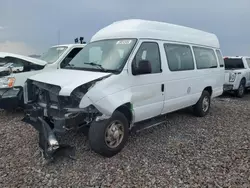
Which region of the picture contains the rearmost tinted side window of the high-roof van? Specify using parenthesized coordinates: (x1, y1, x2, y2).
(193, 47, 218, 69)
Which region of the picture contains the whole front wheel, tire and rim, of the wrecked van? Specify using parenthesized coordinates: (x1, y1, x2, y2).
(89, 111, 129, 157)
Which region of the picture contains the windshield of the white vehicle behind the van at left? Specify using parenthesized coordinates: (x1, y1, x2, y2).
(40, 46, 68, 63)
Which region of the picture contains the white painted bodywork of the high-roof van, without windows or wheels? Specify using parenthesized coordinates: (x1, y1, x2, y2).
(25, 20, 225, 122)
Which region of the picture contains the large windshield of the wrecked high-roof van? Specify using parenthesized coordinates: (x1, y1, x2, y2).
(65, 39, 136, 72)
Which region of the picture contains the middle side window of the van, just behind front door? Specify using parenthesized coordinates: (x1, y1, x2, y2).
(164, 44, 194, 71)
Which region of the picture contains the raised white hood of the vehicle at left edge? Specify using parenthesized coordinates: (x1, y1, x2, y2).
(0, 52, 47, 66)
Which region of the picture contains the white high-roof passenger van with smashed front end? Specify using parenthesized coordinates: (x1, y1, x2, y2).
(23, 19, 225, 158)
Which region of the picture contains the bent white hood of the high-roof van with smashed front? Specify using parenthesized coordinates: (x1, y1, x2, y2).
(29, 69, 111, 96)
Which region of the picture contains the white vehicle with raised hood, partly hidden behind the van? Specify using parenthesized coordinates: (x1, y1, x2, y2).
(0, 44, 85, 110)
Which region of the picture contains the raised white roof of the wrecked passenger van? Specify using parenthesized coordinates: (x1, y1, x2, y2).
(91, 19, 220, 48)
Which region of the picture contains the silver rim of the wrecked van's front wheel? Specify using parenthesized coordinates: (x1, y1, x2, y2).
(105, 120, 124, 148)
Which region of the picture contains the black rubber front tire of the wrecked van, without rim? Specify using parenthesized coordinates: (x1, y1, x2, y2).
(89, 111, 129, 157)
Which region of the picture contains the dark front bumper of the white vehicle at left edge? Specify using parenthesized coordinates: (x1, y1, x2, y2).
(0, 87, 23, 110)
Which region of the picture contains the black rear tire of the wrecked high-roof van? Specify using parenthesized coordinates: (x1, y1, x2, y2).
(194, 90, 211, 117)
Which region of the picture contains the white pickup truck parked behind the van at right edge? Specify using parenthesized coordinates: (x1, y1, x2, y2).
(224, 56, 250, 98)
